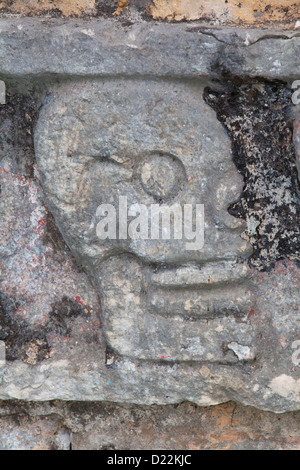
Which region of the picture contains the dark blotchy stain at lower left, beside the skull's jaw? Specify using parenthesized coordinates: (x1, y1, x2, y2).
(0, 292, 91, 365)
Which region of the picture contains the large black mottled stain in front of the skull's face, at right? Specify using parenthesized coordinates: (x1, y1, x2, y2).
(204, 71, 300, 271)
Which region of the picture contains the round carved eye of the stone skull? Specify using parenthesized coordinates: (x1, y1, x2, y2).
(139, 153, 186, 200)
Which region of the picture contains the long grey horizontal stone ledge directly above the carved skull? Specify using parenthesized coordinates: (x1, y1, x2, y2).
(0, 18, 300, 79)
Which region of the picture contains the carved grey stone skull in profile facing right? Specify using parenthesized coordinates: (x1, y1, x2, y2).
(35, 81, 255, 363)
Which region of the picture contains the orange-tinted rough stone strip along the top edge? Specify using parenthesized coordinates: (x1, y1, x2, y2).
(0, 0, 299, 28)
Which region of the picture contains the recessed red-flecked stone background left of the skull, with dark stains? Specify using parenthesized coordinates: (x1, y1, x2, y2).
(0, 94, 99, 364)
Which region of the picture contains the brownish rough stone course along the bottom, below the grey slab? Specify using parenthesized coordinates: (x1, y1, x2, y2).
(0, 402, 300, 450)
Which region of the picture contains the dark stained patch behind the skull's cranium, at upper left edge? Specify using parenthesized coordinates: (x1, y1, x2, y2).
(0, 93, 38, 178)
